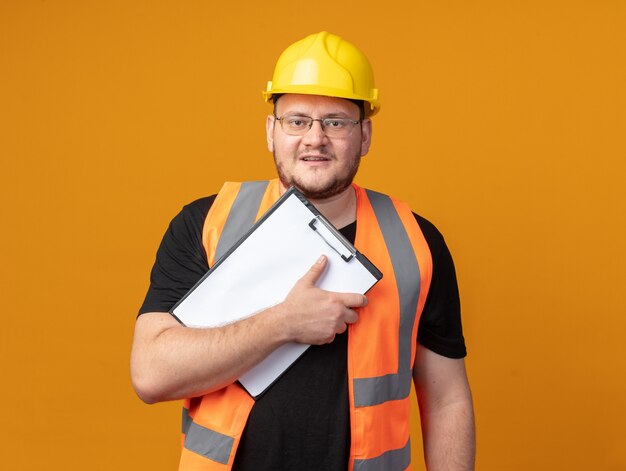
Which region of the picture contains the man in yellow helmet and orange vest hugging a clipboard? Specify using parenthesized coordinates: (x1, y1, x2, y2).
(131, 32, 474, 471)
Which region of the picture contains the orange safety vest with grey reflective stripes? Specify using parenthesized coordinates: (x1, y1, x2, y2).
(179, 180, 432, 471)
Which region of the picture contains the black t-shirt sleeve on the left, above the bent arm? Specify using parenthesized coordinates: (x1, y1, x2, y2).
(139, 195, 215, 315)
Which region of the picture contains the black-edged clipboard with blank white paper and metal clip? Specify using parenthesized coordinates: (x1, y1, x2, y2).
(170, 187, 382, 398)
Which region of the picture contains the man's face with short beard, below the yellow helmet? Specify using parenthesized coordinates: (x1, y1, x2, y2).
(266, 94, 372, 200)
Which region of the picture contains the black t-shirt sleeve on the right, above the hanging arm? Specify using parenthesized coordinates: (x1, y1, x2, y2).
(415, 215, 467, 358)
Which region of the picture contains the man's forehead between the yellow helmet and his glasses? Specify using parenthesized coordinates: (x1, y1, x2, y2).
(276, 94, 359, 119)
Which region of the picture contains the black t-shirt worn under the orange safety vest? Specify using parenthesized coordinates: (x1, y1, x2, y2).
(139, 195, 466, 471)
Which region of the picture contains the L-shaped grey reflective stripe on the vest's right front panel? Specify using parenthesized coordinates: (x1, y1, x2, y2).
(354, 190, 420, 408)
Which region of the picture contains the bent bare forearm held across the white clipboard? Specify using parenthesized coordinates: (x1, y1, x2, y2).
(131, 310, 287, 403)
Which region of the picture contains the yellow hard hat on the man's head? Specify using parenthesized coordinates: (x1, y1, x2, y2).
(263, 31, 380, 116)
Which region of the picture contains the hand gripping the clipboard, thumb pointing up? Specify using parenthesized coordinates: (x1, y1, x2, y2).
(281, 256, 367, 345)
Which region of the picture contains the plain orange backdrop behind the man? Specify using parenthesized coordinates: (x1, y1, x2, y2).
(0, 0, 626, 470)
